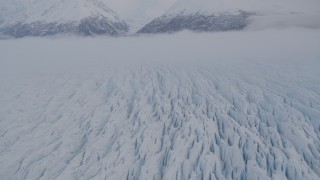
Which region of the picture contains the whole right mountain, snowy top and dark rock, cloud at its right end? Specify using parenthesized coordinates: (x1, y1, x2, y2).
(138, 0, 320, 33)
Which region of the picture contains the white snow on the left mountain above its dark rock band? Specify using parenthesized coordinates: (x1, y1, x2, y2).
(0, 0, 120, 25)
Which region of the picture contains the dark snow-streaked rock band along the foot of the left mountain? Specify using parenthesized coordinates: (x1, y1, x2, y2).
(2, 17, 129, 38)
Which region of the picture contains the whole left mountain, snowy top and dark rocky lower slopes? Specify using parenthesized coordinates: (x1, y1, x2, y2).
(0, 0, 129, 37)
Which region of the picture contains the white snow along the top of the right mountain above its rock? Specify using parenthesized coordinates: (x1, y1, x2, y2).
(167, 0, 320, 14)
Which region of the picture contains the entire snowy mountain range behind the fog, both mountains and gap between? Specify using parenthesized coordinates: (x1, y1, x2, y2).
(0, 0, 320, 37)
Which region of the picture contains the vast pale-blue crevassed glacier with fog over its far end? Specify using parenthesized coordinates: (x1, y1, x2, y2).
(0, 28, 320, 180)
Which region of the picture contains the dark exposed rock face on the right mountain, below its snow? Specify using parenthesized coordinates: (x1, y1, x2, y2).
(138, 12, 249, 33)
